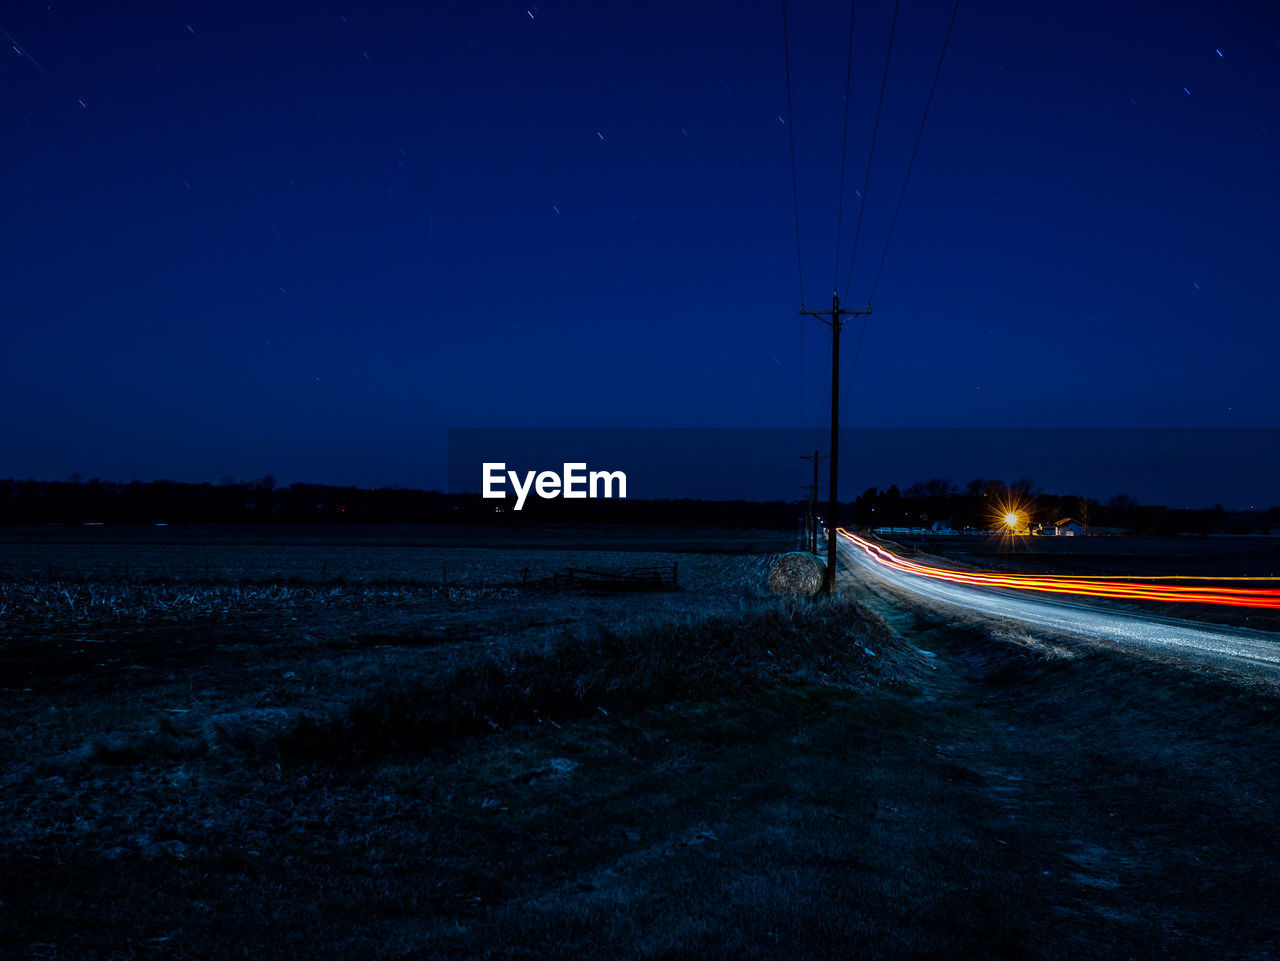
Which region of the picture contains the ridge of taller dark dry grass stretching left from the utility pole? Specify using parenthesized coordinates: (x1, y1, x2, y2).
(282, 601, 919, 760)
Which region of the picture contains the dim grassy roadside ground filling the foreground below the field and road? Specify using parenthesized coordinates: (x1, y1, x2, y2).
(0, 591, 1280, 961)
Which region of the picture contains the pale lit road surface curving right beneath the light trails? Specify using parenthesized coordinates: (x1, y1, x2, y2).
(840, 527, 1280, 679)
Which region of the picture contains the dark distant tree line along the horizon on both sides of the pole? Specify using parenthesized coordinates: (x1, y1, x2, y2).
(0, 475, 1280, 535)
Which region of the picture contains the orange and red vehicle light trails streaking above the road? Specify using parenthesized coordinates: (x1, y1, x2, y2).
(836, 527, 1280, 610)
